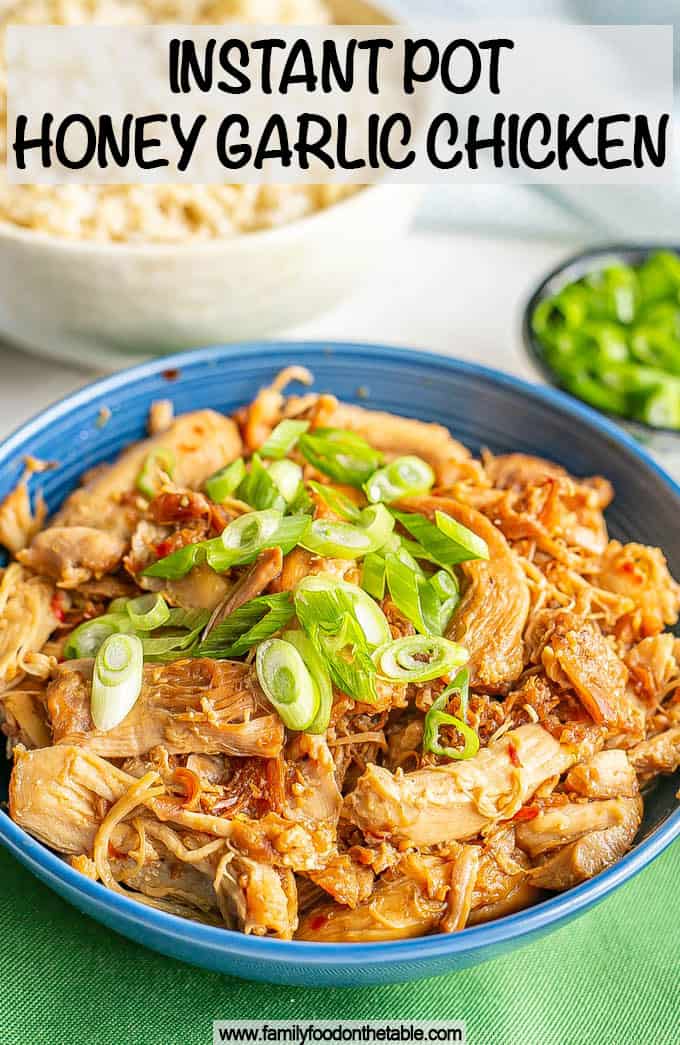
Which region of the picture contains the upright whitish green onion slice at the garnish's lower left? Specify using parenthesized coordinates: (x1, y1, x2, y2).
(90, 634, 144, 732)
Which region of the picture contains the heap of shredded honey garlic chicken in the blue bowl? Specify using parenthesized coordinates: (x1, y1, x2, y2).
(0, 366, 680, 943)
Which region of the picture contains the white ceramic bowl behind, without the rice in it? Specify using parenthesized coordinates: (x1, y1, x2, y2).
(0, 0, 420, 368)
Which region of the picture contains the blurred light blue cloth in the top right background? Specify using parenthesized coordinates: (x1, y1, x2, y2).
(386, 0, 680, 243)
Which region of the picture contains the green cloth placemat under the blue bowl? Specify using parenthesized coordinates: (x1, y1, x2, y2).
(0, 844, 680, 1045)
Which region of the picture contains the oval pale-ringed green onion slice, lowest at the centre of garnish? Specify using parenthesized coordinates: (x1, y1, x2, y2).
(255, 638, 320, 730)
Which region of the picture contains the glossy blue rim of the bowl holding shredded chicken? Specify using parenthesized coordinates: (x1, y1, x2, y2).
(0, 341, 680, 969)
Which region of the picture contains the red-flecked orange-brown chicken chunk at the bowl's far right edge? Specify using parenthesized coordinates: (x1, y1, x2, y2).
(593, 540, 680, 638)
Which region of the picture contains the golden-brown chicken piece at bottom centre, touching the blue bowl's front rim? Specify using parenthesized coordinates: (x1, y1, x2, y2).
(296, 878, 446, 944)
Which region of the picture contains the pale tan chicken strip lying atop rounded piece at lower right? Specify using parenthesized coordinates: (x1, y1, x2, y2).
(515, 798, 632, 857)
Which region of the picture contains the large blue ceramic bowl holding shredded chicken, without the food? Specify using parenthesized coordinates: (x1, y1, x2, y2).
(0, 343, 680, 986)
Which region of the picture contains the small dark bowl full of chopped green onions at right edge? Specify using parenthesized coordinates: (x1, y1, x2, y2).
(523, 246, 680, 457)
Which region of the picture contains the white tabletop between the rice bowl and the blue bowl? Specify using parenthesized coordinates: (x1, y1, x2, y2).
(0, 230, 576, 438)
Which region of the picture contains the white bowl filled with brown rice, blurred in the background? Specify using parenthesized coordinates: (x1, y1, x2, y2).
(0, 0, 420, 368)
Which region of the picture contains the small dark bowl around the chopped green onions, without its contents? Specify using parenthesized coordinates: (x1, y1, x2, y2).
(522, 243, 680, 455)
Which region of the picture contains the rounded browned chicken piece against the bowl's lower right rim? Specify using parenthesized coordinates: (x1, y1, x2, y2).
(527, 796, 642, 891)
